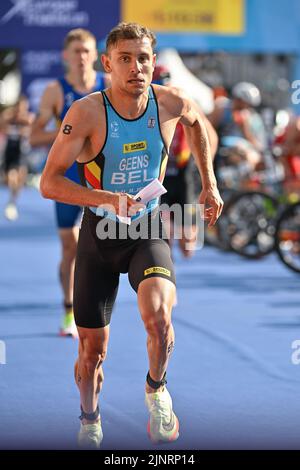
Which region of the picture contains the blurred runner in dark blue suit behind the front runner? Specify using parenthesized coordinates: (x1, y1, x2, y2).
(31, 29, 107, 337)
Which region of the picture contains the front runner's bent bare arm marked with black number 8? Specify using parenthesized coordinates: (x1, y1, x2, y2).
(40, 97, 141, 215)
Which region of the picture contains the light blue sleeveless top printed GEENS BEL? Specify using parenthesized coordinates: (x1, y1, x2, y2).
(78, 87, 168, 220)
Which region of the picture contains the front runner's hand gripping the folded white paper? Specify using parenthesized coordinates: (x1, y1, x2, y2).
(100, 191, 145, 217)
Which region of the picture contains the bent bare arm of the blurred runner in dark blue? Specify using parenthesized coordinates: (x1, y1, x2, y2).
(30, 82, 61, 147)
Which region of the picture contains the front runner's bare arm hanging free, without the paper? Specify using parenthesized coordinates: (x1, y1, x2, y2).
(164, 89, 223, 226)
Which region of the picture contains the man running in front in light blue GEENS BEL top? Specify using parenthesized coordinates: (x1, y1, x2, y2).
(41, 23, 223, 448)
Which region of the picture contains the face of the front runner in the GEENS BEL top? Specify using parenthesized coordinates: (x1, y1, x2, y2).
(102, 37, 156, 96)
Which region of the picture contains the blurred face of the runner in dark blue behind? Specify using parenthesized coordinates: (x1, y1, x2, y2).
(63, 39, 97, 72)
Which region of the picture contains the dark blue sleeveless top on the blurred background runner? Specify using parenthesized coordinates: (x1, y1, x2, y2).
(57, 72, 105, 183)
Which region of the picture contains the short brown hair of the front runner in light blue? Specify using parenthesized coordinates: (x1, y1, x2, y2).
(106, 22, 156, 53)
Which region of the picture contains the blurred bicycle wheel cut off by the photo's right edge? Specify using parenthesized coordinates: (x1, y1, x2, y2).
(275, 202, 300, 273)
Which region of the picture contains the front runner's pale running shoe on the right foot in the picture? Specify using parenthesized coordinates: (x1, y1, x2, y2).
(145, 387, 179, 443)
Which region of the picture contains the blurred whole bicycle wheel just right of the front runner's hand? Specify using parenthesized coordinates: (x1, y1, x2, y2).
(220, 191, 279, 259)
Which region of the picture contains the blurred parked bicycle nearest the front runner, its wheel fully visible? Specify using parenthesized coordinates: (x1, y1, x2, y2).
(208, 143, 282, 259)
